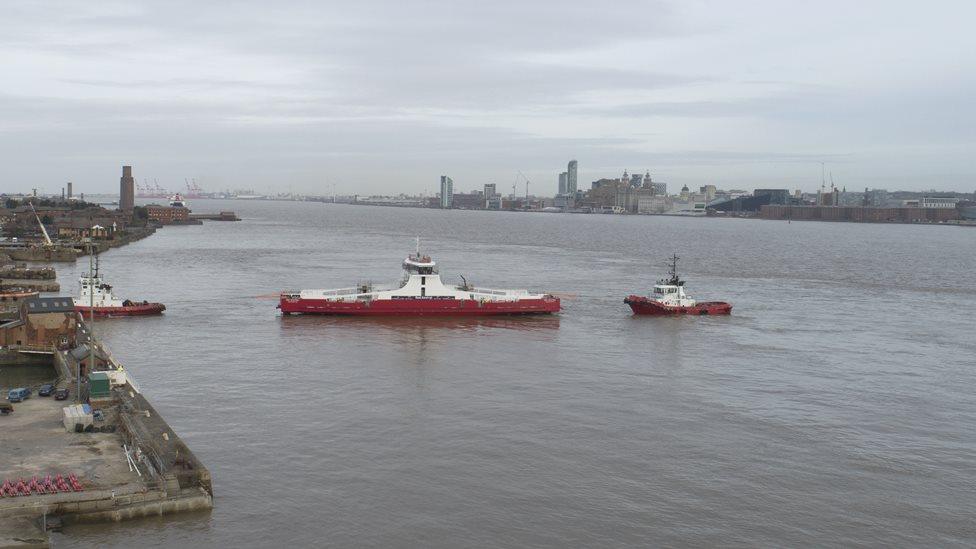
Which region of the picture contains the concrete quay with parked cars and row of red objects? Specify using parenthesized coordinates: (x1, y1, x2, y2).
(0, 338, 213, 549)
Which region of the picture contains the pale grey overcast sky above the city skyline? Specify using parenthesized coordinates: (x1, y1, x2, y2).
(0, 0, 976, 194)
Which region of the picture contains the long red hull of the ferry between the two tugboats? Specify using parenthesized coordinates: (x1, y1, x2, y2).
(278, 296, 559, 316)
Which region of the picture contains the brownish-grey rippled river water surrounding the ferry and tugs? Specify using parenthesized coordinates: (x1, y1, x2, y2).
(53, 200, 976, 548)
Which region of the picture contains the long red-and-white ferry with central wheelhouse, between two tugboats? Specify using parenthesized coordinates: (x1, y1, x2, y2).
(278, 239, 559, 316)
